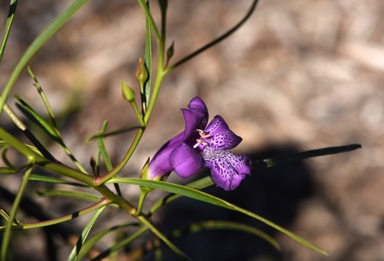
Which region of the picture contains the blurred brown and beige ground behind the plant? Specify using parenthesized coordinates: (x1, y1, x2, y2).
(0, 0, 384, 261)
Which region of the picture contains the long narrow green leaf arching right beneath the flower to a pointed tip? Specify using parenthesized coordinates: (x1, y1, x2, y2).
(109, 178, 328, 255)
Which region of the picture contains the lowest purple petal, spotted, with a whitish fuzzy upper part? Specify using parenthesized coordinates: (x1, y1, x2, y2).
(202, 147, 252, 191)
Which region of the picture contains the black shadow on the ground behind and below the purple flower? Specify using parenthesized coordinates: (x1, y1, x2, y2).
(145, 144, 314, 261)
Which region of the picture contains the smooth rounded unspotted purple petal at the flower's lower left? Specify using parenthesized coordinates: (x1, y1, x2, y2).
(169, 143, 203, 178)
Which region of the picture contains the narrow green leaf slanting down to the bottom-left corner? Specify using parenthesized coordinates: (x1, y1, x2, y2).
(1, 164, 32, 260)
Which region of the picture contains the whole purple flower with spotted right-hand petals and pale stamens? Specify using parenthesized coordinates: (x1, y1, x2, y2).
(148, 97, 252, 190)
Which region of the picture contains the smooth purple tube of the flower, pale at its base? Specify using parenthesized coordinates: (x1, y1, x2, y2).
(148, 132, 184, 179)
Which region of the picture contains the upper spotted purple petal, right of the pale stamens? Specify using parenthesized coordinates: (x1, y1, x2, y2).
(202, 115, 242, 150)
